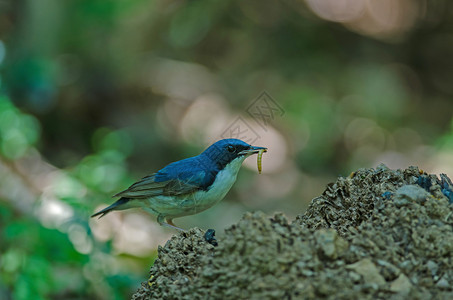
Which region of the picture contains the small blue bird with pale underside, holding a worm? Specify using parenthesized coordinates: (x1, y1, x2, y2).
(91, 139, 267, 231)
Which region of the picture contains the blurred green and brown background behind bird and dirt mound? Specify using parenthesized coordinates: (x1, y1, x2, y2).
(0, 0, 453, 299)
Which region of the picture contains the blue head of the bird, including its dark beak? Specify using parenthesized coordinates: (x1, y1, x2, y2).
(201, 139, 267, 169)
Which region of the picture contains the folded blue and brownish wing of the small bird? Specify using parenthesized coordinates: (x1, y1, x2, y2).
(114, 156, 217, 199)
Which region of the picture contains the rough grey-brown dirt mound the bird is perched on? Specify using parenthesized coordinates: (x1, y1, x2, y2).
(132, 165, 453, 299)
